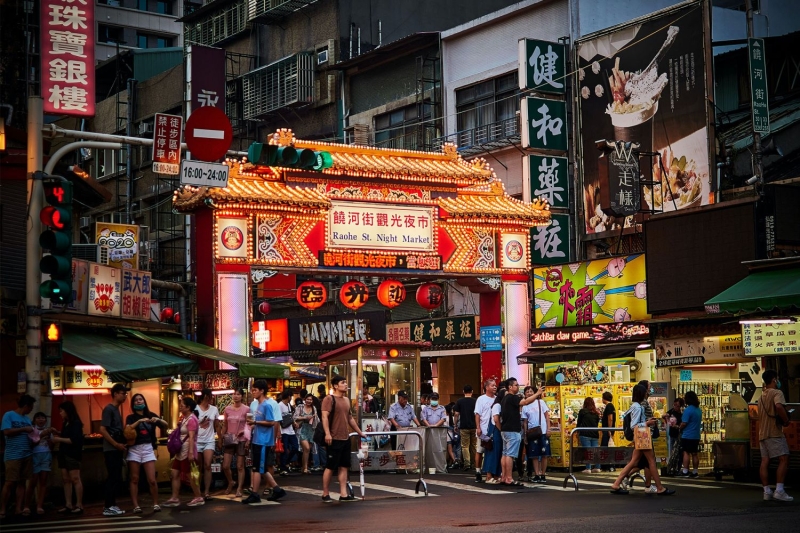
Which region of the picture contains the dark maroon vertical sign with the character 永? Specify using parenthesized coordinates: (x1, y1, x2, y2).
(186, 44, 225, 111)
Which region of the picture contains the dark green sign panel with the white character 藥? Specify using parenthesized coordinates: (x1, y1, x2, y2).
(522, 155, 569, 209)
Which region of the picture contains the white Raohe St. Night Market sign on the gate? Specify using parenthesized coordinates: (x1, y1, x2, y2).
(326, 201, 434, 251)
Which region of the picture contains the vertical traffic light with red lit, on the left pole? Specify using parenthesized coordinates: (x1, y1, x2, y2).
(39, 172, 72, 304)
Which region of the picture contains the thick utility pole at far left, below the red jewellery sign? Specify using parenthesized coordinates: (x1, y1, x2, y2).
(25, 96, 43, 406)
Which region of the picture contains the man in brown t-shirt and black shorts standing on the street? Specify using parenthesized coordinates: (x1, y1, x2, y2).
(320, 376, 366, 503)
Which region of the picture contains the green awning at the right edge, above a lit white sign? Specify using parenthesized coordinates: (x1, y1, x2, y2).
(706, 268, 800, 314)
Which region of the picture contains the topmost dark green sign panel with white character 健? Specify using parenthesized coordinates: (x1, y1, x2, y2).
(518, 39, 567, 94)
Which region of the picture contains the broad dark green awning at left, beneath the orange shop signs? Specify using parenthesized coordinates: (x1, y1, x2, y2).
(63, 333, 198, 382)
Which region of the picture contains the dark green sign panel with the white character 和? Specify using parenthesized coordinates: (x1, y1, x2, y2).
(521, 96, 567, 152)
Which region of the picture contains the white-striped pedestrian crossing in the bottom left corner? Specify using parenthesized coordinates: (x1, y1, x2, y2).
(0, 515, 203, 533)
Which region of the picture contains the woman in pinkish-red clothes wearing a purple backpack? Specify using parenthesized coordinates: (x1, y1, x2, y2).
(164, 396, 206, 507)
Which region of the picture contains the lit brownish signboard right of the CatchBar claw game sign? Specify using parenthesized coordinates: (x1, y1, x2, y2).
(656, 334, 747, 367)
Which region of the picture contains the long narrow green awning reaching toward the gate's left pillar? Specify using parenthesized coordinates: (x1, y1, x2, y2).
(122, 329, 289, 379)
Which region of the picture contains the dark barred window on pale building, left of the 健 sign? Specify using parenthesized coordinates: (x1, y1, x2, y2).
(456, 71, 520, 139)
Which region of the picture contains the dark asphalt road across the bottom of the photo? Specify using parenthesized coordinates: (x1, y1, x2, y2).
(0, 472, 800, 533)
